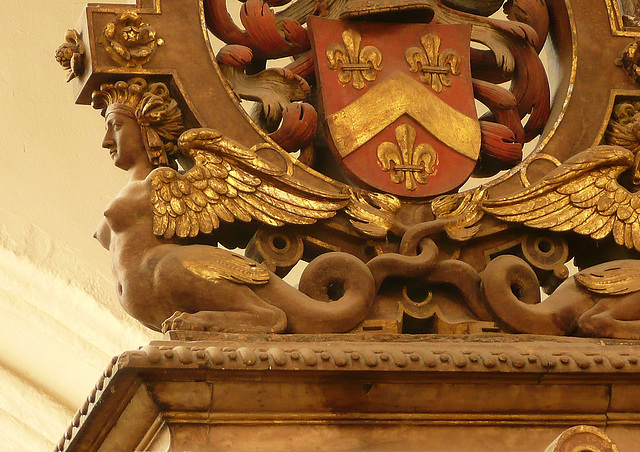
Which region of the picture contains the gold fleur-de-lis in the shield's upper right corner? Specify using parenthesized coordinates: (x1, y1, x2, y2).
(404, 33, 462, 93)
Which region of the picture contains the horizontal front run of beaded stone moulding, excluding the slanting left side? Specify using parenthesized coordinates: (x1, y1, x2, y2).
(120, 332, 640, 373)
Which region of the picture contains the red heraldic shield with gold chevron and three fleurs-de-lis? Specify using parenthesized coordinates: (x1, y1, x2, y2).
(309, 17, 481, 198)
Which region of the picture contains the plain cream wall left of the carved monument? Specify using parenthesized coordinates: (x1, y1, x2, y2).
(0, 0, 158, 451)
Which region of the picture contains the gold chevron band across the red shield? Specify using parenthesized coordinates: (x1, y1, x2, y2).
(327, 71, 481, 160)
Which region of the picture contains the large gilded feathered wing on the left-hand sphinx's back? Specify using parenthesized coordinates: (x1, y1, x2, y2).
(150, 129, 349, 238)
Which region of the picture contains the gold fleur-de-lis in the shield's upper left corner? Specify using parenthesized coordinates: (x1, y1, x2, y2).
(326, 30, 382, 89)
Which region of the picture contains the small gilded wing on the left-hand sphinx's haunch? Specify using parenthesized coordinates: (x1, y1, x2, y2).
(180, 247, 269, 285)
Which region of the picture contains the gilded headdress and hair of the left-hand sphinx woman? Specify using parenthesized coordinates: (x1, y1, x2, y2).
(91, 77, 184, 166)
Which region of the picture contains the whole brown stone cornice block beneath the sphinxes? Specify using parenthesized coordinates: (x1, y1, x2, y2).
(57, 333, 640, 452)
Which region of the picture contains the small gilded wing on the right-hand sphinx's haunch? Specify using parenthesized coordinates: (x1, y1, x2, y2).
(575, 259, 640, 295)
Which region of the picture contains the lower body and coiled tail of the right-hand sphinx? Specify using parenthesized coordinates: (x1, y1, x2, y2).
(482, 256, 640, 339)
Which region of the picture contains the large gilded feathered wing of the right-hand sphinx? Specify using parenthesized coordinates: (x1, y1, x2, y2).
(482, 146, 640, 251)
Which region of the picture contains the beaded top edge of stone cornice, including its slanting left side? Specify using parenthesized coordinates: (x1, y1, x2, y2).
(57, 333, 640, 451)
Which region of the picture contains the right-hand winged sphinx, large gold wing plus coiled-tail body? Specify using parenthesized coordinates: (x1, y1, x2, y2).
(482, 142, 640, 339)
